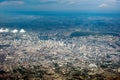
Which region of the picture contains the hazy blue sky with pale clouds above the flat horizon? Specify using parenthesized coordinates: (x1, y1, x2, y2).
(0, 0, 120, 13)
